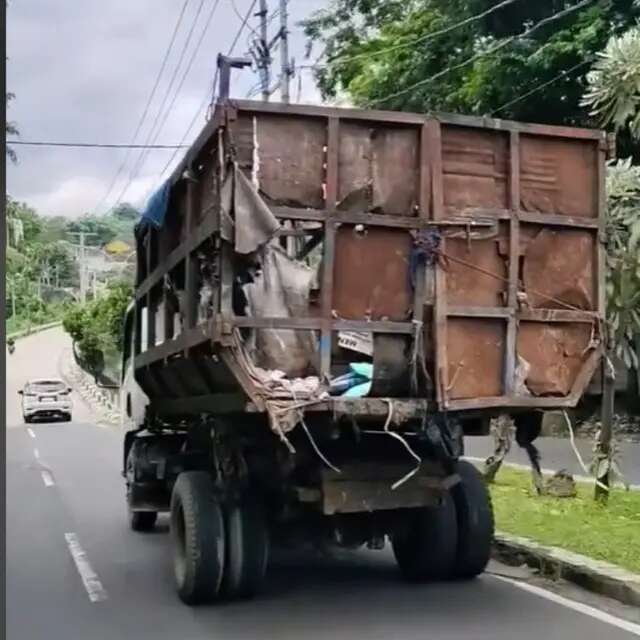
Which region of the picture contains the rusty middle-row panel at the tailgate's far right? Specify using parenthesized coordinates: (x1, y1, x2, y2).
(521, 226, 595, 310)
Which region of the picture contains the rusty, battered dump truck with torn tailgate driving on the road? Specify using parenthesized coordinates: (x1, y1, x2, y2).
(122, 99, 607, 604)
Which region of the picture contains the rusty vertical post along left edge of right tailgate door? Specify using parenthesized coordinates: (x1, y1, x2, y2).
(426, 120, 449, 409)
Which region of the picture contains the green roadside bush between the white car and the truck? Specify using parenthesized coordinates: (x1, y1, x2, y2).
(62, 282, 133, 375)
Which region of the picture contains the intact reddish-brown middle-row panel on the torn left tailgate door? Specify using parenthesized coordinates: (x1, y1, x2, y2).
(333, 225, 412, 321)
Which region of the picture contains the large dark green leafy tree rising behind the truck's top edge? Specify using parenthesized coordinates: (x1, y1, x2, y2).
(303, 0, 640, 135)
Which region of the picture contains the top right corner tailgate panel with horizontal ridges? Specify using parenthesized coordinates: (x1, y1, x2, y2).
(520, 135, 598, 218)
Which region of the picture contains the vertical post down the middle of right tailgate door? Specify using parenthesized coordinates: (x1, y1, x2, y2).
(503, 131, 520, 396)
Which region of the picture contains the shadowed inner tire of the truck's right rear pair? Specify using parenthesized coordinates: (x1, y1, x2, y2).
(391, 495, 458, 582)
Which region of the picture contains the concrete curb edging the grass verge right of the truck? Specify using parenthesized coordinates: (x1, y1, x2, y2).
(493, 531, 640, 607)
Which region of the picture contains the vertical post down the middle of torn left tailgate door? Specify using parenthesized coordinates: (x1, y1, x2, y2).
(320, 117, 340, 380)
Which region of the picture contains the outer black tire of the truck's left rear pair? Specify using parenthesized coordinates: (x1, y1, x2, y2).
(171, 471, 225, 604)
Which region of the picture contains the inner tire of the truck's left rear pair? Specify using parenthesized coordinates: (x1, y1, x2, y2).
(222, 501, 269, 598)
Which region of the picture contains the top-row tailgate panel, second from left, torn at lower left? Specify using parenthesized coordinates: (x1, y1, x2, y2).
(338, 122, 420, 215)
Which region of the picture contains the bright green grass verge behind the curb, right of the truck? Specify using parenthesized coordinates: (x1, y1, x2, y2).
(490, 467, 640, 573)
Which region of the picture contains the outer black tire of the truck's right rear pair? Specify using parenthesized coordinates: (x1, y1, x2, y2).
(451, 461, 494, 578)
